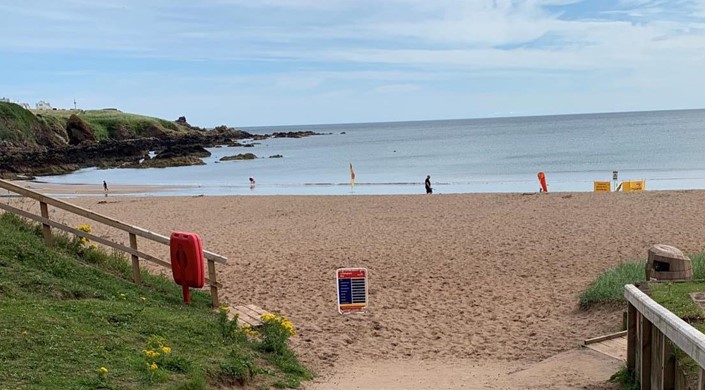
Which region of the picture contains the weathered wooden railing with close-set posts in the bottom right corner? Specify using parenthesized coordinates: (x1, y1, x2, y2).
(624, 284, 705, 390)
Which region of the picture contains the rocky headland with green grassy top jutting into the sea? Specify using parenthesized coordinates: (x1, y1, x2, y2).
(0, 102, 318, 179)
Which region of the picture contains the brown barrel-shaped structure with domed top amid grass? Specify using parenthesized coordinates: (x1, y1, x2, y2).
(646, 244, 693, 280)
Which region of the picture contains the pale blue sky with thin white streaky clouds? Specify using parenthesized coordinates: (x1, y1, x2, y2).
(0, 0, 705, 127)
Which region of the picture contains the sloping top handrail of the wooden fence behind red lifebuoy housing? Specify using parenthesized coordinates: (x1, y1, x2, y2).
(0, 180, 228, 264)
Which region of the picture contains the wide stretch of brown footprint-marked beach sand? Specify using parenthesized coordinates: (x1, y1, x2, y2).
(11, 191, 705, 389)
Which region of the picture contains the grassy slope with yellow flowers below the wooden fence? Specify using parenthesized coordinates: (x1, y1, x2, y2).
(0, 213, 311, 389)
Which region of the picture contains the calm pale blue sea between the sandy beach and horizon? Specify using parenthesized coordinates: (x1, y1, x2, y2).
(41, 110, 705, 195)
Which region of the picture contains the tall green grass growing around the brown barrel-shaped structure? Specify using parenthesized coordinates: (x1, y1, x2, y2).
(580, 252, 705, 308)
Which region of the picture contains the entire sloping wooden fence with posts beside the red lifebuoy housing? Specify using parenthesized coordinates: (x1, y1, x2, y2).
(0, 180, 228, 307)
